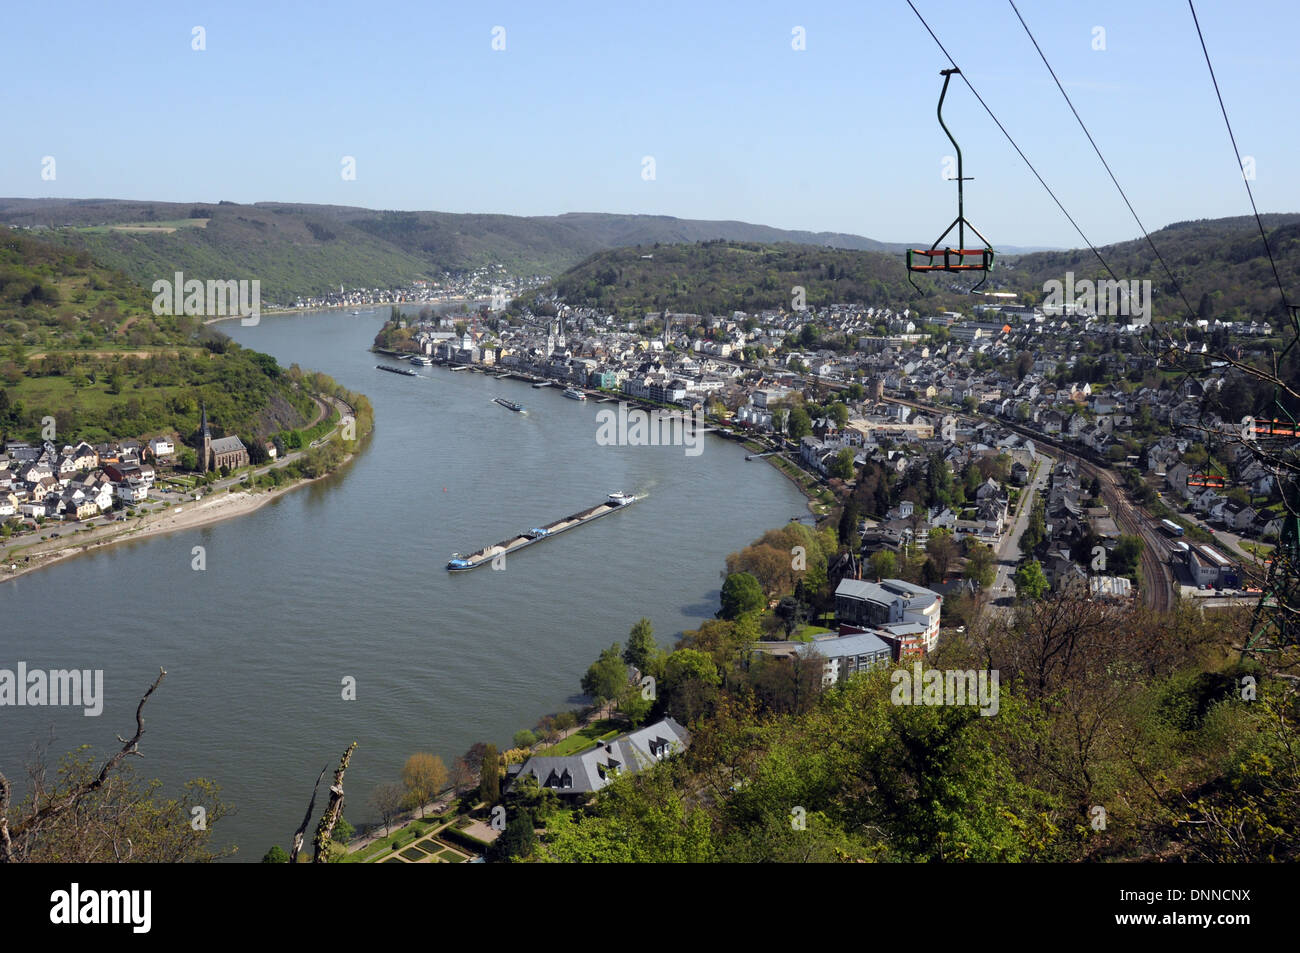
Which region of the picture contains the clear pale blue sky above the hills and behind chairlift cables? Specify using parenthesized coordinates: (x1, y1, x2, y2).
(0, 0, 1300, 247)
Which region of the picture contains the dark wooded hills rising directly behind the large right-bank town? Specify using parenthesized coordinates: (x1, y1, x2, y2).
(541, 215, 1300, 319)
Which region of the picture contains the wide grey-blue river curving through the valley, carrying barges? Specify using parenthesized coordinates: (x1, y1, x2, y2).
(0, 308, 806, 861)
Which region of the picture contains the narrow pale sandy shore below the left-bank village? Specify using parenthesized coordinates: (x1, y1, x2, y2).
(0, 454, 352, 582)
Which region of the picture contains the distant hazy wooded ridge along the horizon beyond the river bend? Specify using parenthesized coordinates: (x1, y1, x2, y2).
(0, 199, 902, 302)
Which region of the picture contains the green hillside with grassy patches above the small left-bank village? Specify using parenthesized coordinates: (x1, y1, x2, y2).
(0, 228, 323, 443)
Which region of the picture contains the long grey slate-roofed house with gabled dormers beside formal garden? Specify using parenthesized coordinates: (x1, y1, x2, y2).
(506, 718, 690, 796)
